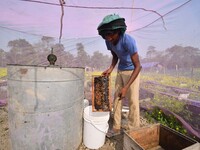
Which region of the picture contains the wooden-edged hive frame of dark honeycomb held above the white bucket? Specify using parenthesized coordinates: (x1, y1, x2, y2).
(92, 75, 111, 112)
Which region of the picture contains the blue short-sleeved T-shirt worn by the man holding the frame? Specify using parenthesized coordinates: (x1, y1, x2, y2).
(106, 34, 138, 71)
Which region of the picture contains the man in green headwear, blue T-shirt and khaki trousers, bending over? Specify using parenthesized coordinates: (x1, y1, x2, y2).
(97, 14, 141, 137)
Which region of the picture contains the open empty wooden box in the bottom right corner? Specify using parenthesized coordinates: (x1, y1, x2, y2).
(123, 124, 200, 150)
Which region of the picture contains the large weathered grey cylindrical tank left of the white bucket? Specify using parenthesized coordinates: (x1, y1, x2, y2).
(8, 65, 84, 150)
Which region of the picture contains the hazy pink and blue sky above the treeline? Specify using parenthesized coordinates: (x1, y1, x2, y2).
(0, 0, 200, 57)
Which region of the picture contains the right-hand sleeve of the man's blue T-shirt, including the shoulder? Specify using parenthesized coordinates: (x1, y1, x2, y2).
(124, 35, 138, 55)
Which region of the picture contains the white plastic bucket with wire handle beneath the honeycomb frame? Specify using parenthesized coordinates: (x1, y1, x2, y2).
(83, 106, 110, 149)
